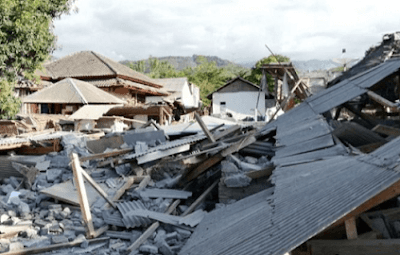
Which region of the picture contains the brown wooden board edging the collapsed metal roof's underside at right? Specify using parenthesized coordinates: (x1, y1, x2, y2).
(332, 177, 400, 226)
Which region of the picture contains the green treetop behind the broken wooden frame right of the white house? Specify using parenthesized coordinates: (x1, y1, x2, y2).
(245, 55, 290, 92)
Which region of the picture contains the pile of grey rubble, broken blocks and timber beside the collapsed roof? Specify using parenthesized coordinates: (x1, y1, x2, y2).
(0, 112, 273, 254)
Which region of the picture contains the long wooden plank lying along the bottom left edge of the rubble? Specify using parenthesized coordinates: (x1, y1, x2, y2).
(2, 237, 110, 255)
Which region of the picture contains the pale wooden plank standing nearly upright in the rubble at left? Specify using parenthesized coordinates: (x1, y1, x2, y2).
(71, 153, 95, 238)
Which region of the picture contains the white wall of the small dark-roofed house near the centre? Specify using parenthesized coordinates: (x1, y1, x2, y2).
(212, 91, 266, 119)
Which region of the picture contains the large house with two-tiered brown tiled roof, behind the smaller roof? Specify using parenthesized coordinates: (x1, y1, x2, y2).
(40, 51, 168, 105)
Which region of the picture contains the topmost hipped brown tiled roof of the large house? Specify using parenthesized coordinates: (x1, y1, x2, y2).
(43, 51, 162, 88)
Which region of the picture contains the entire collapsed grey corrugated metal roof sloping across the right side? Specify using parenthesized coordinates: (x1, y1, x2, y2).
(180, 60, 400, 255)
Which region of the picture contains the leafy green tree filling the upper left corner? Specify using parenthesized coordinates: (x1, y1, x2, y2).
(0, 0, 74, 118)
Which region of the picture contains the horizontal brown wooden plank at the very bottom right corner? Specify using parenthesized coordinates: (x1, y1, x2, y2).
(307, 239, 400, 255)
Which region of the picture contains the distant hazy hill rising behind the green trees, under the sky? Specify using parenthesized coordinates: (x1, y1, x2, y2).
(120, 55, 247, 71)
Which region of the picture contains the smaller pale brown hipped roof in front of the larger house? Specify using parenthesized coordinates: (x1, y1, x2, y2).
(22, 78, 125, 104)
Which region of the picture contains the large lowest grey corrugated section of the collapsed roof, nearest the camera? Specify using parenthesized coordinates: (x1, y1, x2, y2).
(180, 154, 400, 254)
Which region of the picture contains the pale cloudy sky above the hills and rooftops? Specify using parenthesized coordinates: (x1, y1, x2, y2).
(53, 0, 400, 62)
